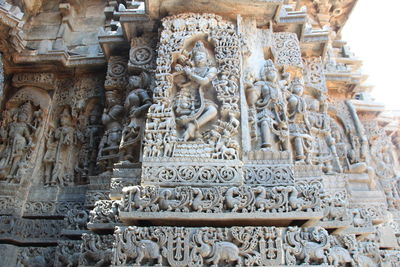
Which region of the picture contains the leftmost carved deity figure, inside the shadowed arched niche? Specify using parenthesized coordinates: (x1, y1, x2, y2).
(2, 102, 33, 181)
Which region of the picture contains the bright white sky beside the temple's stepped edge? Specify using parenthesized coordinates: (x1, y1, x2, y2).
(342, 0, 400, 110)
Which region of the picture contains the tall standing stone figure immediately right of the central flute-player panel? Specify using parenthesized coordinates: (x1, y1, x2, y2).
(255, 59, 289, 150)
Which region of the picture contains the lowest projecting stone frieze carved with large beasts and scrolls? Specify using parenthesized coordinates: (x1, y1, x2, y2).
(108, 226, 377, 266)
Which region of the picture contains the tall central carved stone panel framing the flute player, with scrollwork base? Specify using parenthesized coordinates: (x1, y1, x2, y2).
(142, 14, 241, 187)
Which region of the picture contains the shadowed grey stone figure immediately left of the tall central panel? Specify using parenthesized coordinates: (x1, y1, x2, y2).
(120, 76, 152, 162)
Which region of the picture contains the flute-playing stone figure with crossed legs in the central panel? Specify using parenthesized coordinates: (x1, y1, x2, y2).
(174, 41, 218, 141)
